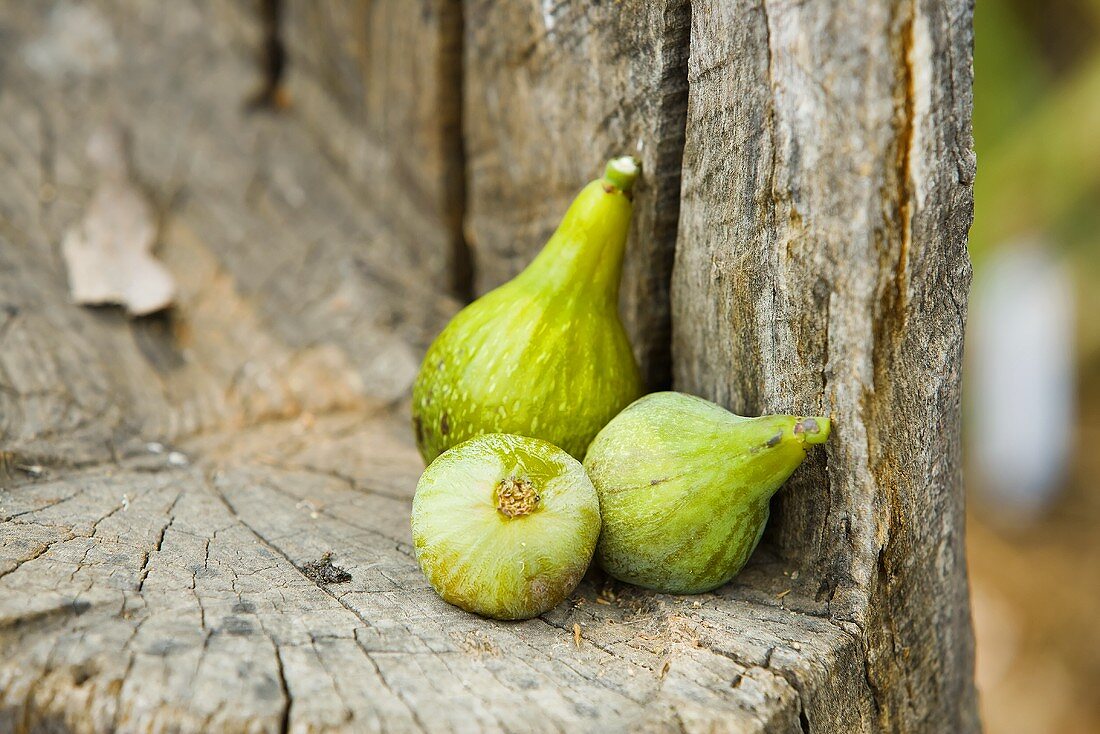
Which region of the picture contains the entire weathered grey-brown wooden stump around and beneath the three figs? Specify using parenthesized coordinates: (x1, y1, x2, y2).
(0, 0, 975, 732)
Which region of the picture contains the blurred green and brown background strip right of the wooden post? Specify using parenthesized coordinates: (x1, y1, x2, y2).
(966, 0, 1100, 734)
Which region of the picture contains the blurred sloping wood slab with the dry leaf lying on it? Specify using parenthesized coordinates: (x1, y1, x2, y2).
(0, 2, 453, 464)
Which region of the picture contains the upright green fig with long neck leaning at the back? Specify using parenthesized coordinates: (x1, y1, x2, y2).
(413, 157, 642, 461)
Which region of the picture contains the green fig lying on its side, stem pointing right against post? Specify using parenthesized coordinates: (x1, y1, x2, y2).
(584, 392, 831, 594)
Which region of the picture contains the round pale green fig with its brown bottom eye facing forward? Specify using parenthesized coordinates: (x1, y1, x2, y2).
(413, 434, 601, 620)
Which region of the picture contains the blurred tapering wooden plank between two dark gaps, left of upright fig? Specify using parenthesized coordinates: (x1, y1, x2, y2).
(281, 0, 470, 295)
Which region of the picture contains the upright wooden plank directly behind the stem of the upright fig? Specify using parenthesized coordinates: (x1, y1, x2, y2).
(464, 0, 690, 387)
